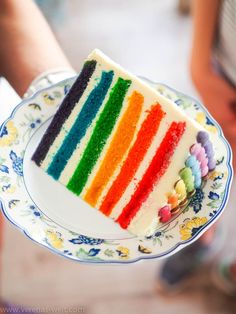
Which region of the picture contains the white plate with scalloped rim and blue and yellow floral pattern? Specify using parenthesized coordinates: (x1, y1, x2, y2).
(0, 78, 232, 263)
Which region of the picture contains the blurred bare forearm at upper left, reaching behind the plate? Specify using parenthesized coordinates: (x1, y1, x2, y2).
(0, 0, 70, 95)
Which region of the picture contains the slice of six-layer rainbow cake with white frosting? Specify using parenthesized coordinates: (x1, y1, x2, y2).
(32, 50, 215, 235)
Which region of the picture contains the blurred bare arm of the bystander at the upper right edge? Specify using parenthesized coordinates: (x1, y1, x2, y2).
(191, 0, 236, 105)
